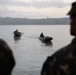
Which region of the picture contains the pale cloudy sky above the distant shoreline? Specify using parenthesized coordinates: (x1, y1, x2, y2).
(0, 0, 76, 19)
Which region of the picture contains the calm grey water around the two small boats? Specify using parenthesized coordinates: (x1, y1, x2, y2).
(0, 25, 73, 75)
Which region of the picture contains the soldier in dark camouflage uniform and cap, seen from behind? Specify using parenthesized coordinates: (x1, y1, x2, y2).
(41, 2, 76, 75)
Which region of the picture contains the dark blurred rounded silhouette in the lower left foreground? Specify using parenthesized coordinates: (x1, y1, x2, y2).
(0, 39, 15, 75)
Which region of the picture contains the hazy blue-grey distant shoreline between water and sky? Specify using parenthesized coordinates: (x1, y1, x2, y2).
(0, 17, 69, 25)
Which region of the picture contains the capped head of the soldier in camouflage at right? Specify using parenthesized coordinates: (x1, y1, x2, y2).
(67, 2, 76, 36)
